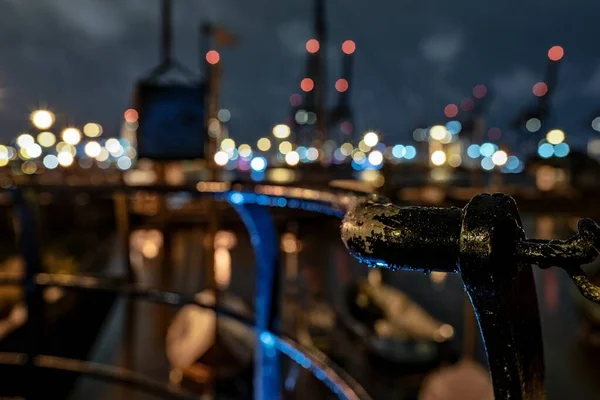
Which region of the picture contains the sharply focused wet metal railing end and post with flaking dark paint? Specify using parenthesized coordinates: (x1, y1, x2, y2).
(341, 194, 600, 399)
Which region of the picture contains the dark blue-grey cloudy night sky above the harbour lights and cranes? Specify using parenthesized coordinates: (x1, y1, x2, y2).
(0, 0, 600, 152)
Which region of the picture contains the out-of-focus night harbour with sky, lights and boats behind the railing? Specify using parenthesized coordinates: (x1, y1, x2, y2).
(0, 0, 600, 399)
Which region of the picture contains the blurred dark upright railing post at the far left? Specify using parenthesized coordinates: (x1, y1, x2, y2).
(13, 189, 44, 399)
